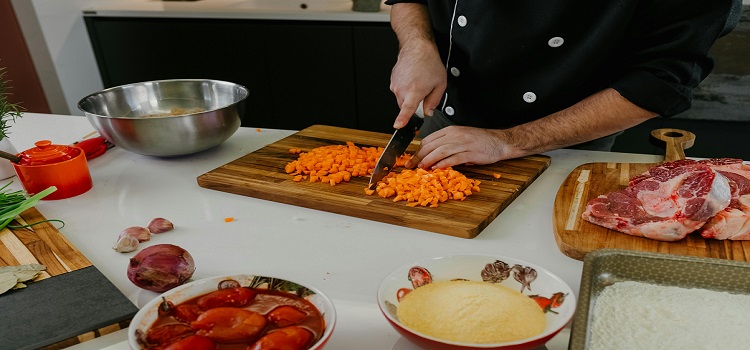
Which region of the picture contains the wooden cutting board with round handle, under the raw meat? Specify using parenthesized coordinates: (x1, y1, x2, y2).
(553, 129, 750, 261)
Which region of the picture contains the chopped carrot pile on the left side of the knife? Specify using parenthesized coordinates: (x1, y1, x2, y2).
(284, 142, 411, 186)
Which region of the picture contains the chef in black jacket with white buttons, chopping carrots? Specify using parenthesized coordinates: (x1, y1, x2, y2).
(386, 0, 741, 168)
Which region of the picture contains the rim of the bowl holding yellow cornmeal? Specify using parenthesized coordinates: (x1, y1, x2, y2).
(377, 253, 578, 349)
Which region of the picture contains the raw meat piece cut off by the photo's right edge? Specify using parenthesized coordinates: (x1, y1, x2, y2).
(700, 158, 750, 240)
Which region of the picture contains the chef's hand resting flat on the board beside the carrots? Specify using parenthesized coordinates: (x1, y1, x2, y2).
(406, 125, 521, 169)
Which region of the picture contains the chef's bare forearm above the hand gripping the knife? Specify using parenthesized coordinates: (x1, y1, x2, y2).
(391, 3, 437, 50)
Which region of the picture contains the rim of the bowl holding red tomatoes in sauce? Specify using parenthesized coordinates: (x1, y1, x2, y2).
(127, 273, 337, 349)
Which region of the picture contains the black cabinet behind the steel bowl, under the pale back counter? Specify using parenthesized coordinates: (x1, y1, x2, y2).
(85, 16, 398, 133)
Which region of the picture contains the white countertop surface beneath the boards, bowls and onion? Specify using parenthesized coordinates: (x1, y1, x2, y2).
(3, 113, 660, 350)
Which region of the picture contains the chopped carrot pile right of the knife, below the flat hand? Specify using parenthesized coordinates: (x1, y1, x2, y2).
(365, 167, 481, 208)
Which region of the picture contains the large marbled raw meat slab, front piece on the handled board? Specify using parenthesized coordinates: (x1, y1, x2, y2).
(582, 159, 732, 241)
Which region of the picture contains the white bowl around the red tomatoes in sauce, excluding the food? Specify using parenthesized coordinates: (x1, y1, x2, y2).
(128, 274, 336, 350)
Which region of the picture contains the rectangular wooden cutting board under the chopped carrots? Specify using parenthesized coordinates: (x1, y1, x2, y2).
(197, 125, 551, 238)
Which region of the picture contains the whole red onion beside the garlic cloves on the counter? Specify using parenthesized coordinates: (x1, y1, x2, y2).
(128, 244, 195, 293)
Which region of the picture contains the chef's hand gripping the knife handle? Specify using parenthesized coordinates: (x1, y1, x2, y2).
(391, 41, 448, 129)
